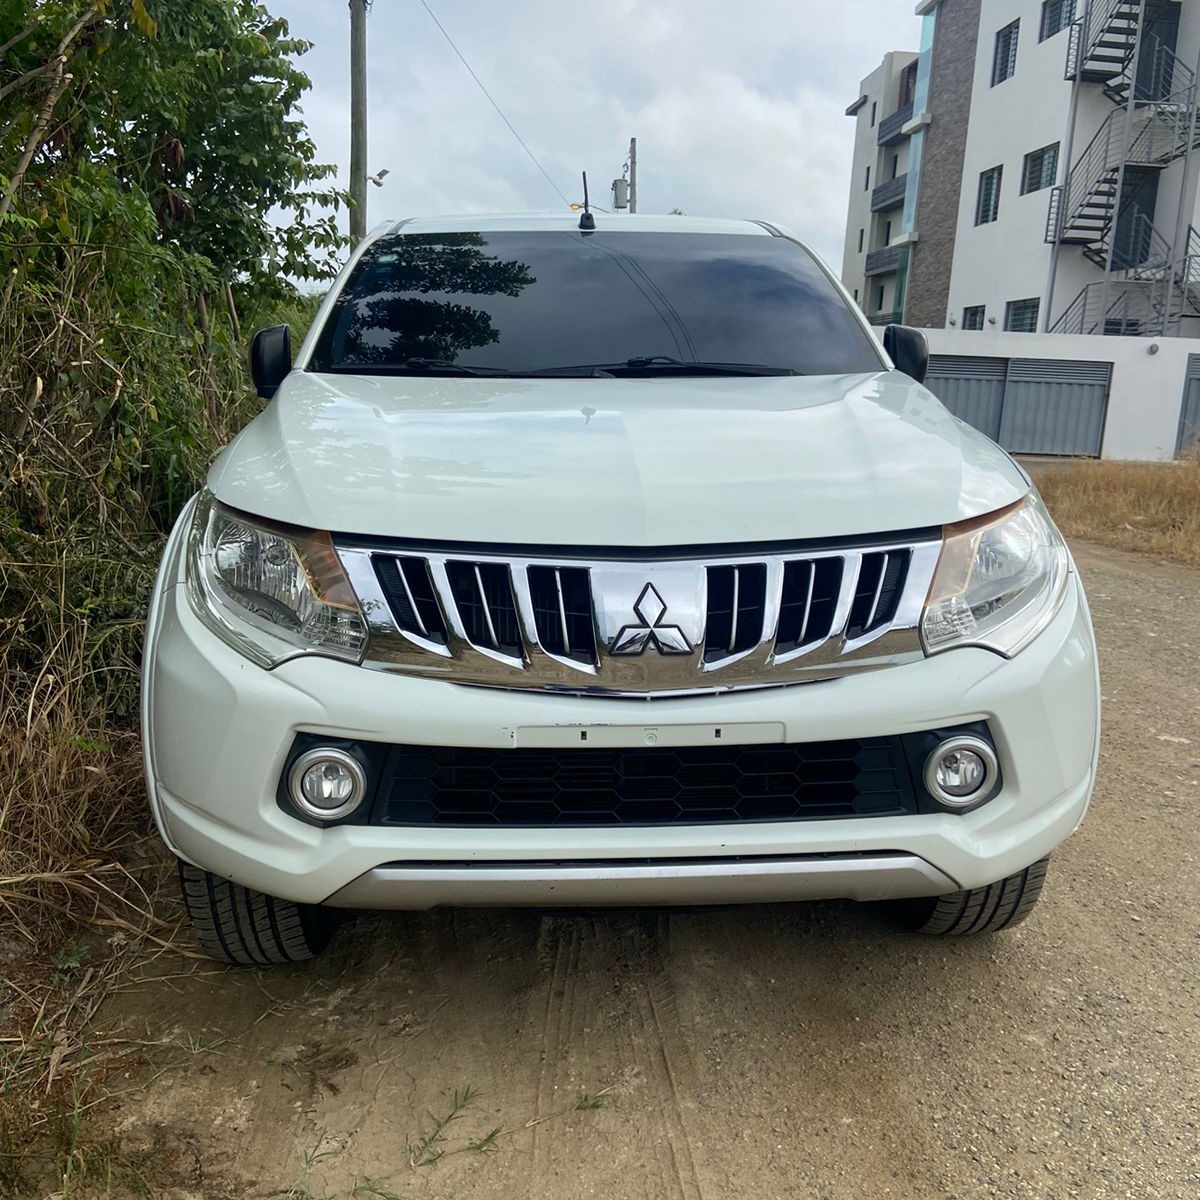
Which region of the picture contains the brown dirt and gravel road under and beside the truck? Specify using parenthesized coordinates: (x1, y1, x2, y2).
(98, 547, 1200, 1200)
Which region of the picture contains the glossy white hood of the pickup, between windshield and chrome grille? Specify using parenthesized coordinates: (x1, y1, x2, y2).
(209, 371, 1028, 547)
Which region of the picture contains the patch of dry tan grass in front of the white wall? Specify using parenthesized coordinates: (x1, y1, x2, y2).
(1032, 452, 1200, 566)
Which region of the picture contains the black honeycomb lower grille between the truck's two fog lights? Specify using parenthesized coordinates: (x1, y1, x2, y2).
(371, 737, 917, 827)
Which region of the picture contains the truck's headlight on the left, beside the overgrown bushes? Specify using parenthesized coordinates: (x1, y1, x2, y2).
(187, 492, 367, 667)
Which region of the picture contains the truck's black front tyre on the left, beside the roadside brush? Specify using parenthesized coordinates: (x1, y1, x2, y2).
(179, 859, 337, 966)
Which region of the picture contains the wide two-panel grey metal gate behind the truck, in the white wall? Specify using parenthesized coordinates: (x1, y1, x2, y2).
(926, 354, 1108, 458)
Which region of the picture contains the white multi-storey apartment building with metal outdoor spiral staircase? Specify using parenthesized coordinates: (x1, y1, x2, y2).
(842, 0, 1200, 336)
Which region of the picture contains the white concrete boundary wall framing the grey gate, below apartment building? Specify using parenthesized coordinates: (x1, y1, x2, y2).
(925, 329, 1200, 461)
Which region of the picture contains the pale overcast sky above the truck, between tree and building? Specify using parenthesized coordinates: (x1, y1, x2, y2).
(268, 0, 919, 269)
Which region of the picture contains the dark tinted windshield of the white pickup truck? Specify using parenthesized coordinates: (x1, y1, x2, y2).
(310, 229, 882, 376)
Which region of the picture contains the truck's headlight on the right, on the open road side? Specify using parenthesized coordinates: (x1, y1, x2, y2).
(920, 494, 1069, 658)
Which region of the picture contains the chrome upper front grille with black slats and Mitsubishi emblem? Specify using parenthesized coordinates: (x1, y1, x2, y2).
(337, 539, 941, 696)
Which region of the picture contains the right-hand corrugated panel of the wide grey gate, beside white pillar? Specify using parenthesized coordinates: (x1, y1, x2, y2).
(996, 359, 1112, 458)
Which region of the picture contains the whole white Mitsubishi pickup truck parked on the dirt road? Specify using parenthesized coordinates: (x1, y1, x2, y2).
(143, 214, 1099, 964)
